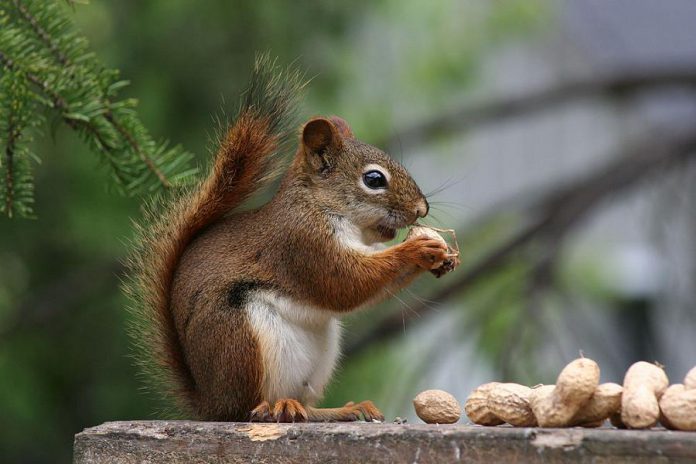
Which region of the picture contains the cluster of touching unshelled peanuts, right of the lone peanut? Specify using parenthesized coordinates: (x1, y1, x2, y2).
(464, 358, 696, 430)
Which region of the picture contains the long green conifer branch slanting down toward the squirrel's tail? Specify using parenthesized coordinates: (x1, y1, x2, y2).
(0, 0, 196, 216)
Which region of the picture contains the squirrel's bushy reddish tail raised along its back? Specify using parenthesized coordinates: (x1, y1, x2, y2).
(124, 55, 304, 412)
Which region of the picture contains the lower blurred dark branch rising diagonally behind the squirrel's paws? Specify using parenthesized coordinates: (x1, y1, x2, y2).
(346, 126, 696, 355)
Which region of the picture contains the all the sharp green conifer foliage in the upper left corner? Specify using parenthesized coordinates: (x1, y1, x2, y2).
(0, 0, 195, 217)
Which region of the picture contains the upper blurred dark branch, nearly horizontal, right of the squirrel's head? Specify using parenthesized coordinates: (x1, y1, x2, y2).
(378, 67, 696, 151)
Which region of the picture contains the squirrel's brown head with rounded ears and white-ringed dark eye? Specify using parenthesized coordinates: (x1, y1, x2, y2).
(296, 116, 429, 241)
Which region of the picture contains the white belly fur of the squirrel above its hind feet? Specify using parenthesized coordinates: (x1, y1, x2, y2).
(246, 290, 341, 405)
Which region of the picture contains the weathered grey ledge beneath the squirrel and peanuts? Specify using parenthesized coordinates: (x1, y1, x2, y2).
(74, 421, 696, 464)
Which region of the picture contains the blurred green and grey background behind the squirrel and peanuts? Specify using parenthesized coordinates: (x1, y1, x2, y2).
(0, 0, 696, 463)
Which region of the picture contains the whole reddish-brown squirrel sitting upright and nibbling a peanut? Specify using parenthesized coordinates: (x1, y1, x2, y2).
(125, 56, 456, 422)
